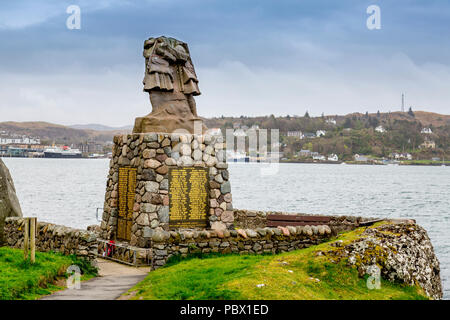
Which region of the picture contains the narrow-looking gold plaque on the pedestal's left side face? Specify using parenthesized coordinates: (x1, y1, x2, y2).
(117, 167, 136, 241)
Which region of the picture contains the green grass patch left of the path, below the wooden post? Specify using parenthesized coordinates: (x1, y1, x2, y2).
(0, 247, 96, 300)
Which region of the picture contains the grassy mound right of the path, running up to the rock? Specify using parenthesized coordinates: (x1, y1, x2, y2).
(129, 225, 427, 300)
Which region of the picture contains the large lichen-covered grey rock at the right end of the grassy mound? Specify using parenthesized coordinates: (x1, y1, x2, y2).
(325, 222, 442, 299)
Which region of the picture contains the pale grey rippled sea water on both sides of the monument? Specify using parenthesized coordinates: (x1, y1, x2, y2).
(3, 158, 450, 299)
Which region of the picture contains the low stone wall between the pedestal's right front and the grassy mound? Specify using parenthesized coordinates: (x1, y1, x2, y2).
(152, 226, 332, 269)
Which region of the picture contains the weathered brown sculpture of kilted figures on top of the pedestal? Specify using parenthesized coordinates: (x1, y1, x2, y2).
(133, 37, 206, 133)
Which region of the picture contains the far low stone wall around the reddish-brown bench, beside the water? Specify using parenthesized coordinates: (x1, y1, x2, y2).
(234, 209, 375, 235)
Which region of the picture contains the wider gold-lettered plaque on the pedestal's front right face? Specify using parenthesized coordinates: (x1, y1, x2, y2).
(169, 167, 209, 228)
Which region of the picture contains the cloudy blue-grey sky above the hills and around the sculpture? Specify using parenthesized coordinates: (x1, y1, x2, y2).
(0, 0, 450, 126)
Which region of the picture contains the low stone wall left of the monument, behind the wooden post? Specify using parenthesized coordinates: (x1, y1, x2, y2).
(5, 218, 98, 261)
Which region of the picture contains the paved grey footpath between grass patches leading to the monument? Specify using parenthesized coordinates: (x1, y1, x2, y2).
(41, 259, 150, 300)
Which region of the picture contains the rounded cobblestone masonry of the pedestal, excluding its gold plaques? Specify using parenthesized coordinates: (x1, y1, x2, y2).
(101, 133, 234, 248)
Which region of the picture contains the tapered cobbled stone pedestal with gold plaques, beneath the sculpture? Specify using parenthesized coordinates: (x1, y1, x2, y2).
(101, 133, 234, 248)
